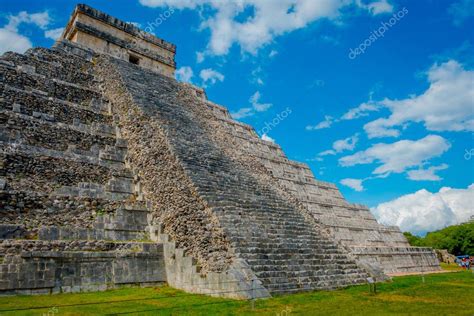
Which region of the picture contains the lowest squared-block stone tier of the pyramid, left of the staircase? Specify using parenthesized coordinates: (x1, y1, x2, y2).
(0, 241, 166, 295)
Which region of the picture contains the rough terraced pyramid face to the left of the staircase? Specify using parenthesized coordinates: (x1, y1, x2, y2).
(0, 48, 166, 295)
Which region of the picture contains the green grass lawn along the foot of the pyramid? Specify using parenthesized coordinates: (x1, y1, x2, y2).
(0, 271, 474, 316)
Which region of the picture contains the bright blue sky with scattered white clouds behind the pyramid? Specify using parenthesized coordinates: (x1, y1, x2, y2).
(0, 0, 474, 234)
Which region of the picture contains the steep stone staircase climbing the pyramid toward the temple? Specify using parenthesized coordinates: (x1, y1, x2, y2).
(100, 59, 367, 294)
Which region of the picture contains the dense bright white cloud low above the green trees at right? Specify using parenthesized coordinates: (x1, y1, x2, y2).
(371, 184, 474, 234)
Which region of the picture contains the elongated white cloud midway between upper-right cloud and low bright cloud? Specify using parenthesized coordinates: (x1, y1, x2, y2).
(339, 135, 451, 176)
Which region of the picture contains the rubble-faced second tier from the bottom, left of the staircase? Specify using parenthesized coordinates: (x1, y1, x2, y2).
(0, 191, 149, 239)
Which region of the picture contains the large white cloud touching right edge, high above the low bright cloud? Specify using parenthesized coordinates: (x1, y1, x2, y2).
(364, 60, 474, 138)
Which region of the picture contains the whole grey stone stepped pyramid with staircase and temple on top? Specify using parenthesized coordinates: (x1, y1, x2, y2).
(0, 5, 439, 298)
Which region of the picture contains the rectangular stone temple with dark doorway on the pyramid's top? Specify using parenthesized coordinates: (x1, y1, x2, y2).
(61, 4, 176, 77)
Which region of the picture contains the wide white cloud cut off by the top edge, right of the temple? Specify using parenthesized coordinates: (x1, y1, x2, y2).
(140, 0, 390, 55)
